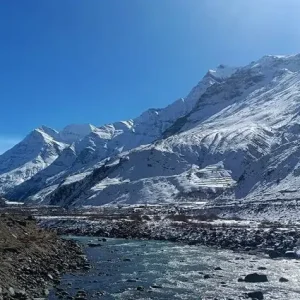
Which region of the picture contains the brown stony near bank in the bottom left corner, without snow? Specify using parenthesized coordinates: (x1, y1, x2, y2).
(0, 213, 86, 300)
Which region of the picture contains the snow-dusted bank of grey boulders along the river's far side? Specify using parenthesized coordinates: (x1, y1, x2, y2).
(40, 206, 300, 258)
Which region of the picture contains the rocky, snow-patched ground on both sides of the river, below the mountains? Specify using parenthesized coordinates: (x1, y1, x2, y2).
(0, 203, 300, 299)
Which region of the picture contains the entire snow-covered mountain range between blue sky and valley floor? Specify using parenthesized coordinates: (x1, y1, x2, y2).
(0, 55, 300, 205)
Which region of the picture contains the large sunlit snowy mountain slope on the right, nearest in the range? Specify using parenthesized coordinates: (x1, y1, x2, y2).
(36, 55, 300, 205)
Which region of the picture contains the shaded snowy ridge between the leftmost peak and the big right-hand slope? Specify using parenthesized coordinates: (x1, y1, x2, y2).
(0, 66, 236, 200)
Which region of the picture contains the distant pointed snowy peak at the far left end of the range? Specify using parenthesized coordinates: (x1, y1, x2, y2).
(0, 124, 96, 193)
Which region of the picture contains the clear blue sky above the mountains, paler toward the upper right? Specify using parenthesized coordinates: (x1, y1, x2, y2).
(0, 0, 300, 152)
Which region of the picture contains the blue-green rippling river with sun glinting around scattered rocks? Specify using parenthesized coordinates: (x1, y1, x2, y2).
(49, 237, 300, 300)
